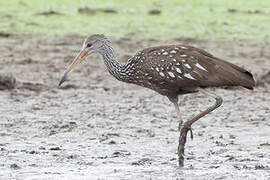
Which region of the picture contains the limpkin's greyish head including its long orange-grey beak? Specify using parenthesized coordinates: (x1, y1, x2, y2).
(59, 34, 109, 86)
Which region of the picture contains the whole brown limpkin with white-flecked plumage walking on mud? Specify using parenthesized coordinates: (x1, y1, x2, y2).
(59, 34, 255, 166)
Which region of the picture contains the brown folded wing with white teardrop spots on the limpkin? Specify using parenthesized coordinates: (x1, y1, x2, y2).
(135, 45, 255, 88)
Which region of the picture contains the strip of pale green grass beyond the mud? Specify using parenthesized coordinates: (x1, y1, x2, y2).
(0, 0, 270, 41)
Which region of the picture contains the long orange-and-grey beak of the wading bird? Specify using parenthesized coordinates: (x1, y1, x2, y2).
(58, 48, 89, 86)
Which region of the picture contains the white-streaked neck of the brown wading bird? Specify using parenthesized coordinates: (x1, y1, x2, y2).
(101, 42, 127, 81)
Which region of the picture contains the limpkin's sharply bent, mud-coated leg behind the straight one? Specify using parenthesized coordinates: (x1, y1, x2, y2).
(178, 90, 223, 167)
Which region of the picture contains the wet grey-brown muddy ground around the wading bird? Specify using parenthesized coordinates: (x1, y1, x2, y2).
(0, 36, 270, 179)
